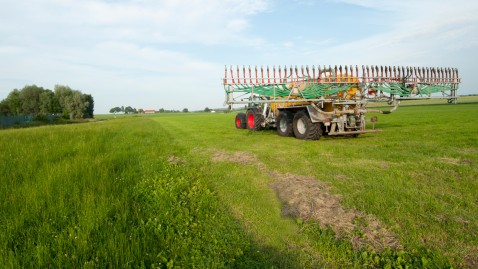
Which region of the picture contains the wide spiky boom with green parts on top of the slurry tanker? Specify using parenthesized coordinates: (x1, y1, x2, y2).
(223, 65, 461, 104)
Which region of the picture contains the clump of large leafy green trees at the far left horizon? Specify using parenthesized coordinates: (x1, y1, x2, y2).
(0, 85, 94, 119)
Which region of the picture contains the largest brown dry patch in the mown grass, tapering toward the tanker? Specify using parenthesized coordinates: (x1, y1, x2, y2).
(212, 150, 402, 250)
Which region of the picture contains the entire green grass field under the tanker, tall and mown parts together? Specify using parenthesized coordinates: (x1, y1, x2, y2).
(0, 99, 478, 268)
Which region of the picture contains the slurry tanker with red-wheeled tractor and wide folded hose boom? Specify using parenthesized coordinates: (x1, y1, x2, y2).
(223, 66, 460, 140)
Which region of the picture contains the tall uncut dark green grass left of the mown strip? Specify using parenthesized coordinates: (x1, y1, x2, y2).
(0, 118, 262, 268)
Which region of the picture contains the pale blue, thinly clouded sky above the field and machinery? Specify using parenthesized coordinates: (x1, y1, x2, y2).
(0, 0, 478, 114)
